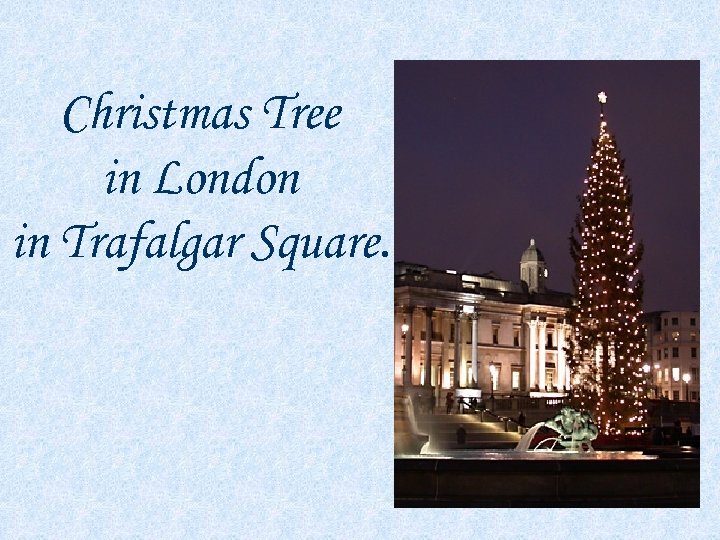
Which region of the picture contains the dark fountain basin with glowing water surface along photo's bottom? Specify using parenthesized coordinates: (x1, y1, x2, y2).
(395, 451, 700, 507)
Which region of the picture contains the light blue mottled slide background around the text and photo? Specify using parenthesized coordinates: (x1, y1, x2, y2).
(0, 1, 720, 539)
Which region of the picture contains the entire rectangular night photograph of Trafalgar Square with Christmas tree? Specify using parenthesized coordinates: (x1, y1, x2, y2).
(394, 61, 701, 508)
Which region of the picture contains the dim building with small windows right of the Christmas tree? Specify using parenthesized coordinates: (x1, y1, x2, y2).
(643, 311, 700, 401)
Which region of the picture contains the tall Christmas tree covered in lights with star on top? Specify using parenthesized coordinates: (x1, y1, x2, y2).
(568, 92, 647, 434)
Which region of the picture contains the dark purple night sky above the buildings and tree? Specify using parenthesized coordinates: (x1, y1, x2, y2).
(395, 61, 700, 312)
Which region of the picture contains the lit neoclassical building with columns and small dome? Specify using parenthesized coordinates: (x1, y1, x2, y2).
(394, 240, 572, 396)
